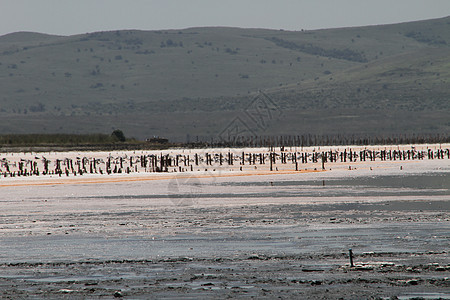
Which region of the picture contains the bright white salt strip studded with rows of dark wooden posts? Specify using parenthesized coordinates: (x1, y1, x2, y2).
(0, 144, 450, 187)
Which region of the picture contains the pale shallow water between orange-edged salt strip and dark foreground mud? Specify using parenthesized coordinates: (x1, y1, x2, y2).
(0, 173, 450, 262)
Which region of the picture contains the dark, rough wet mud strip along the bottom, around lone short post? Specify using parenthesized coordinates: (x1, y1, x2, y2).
(0, 253, 450, 299)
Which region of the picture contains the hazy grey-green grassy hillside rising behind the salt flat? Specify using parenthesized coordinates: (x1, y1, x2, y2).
(0, 17, 450, 141)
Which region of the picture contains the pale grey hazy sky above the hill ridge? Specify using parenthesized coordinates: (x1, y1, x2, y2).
(0, 0, 450, 35)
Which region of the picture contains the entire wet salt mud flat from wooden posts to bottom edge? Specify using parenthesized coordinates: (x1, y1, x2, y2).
(0, 145, 450, 299)
